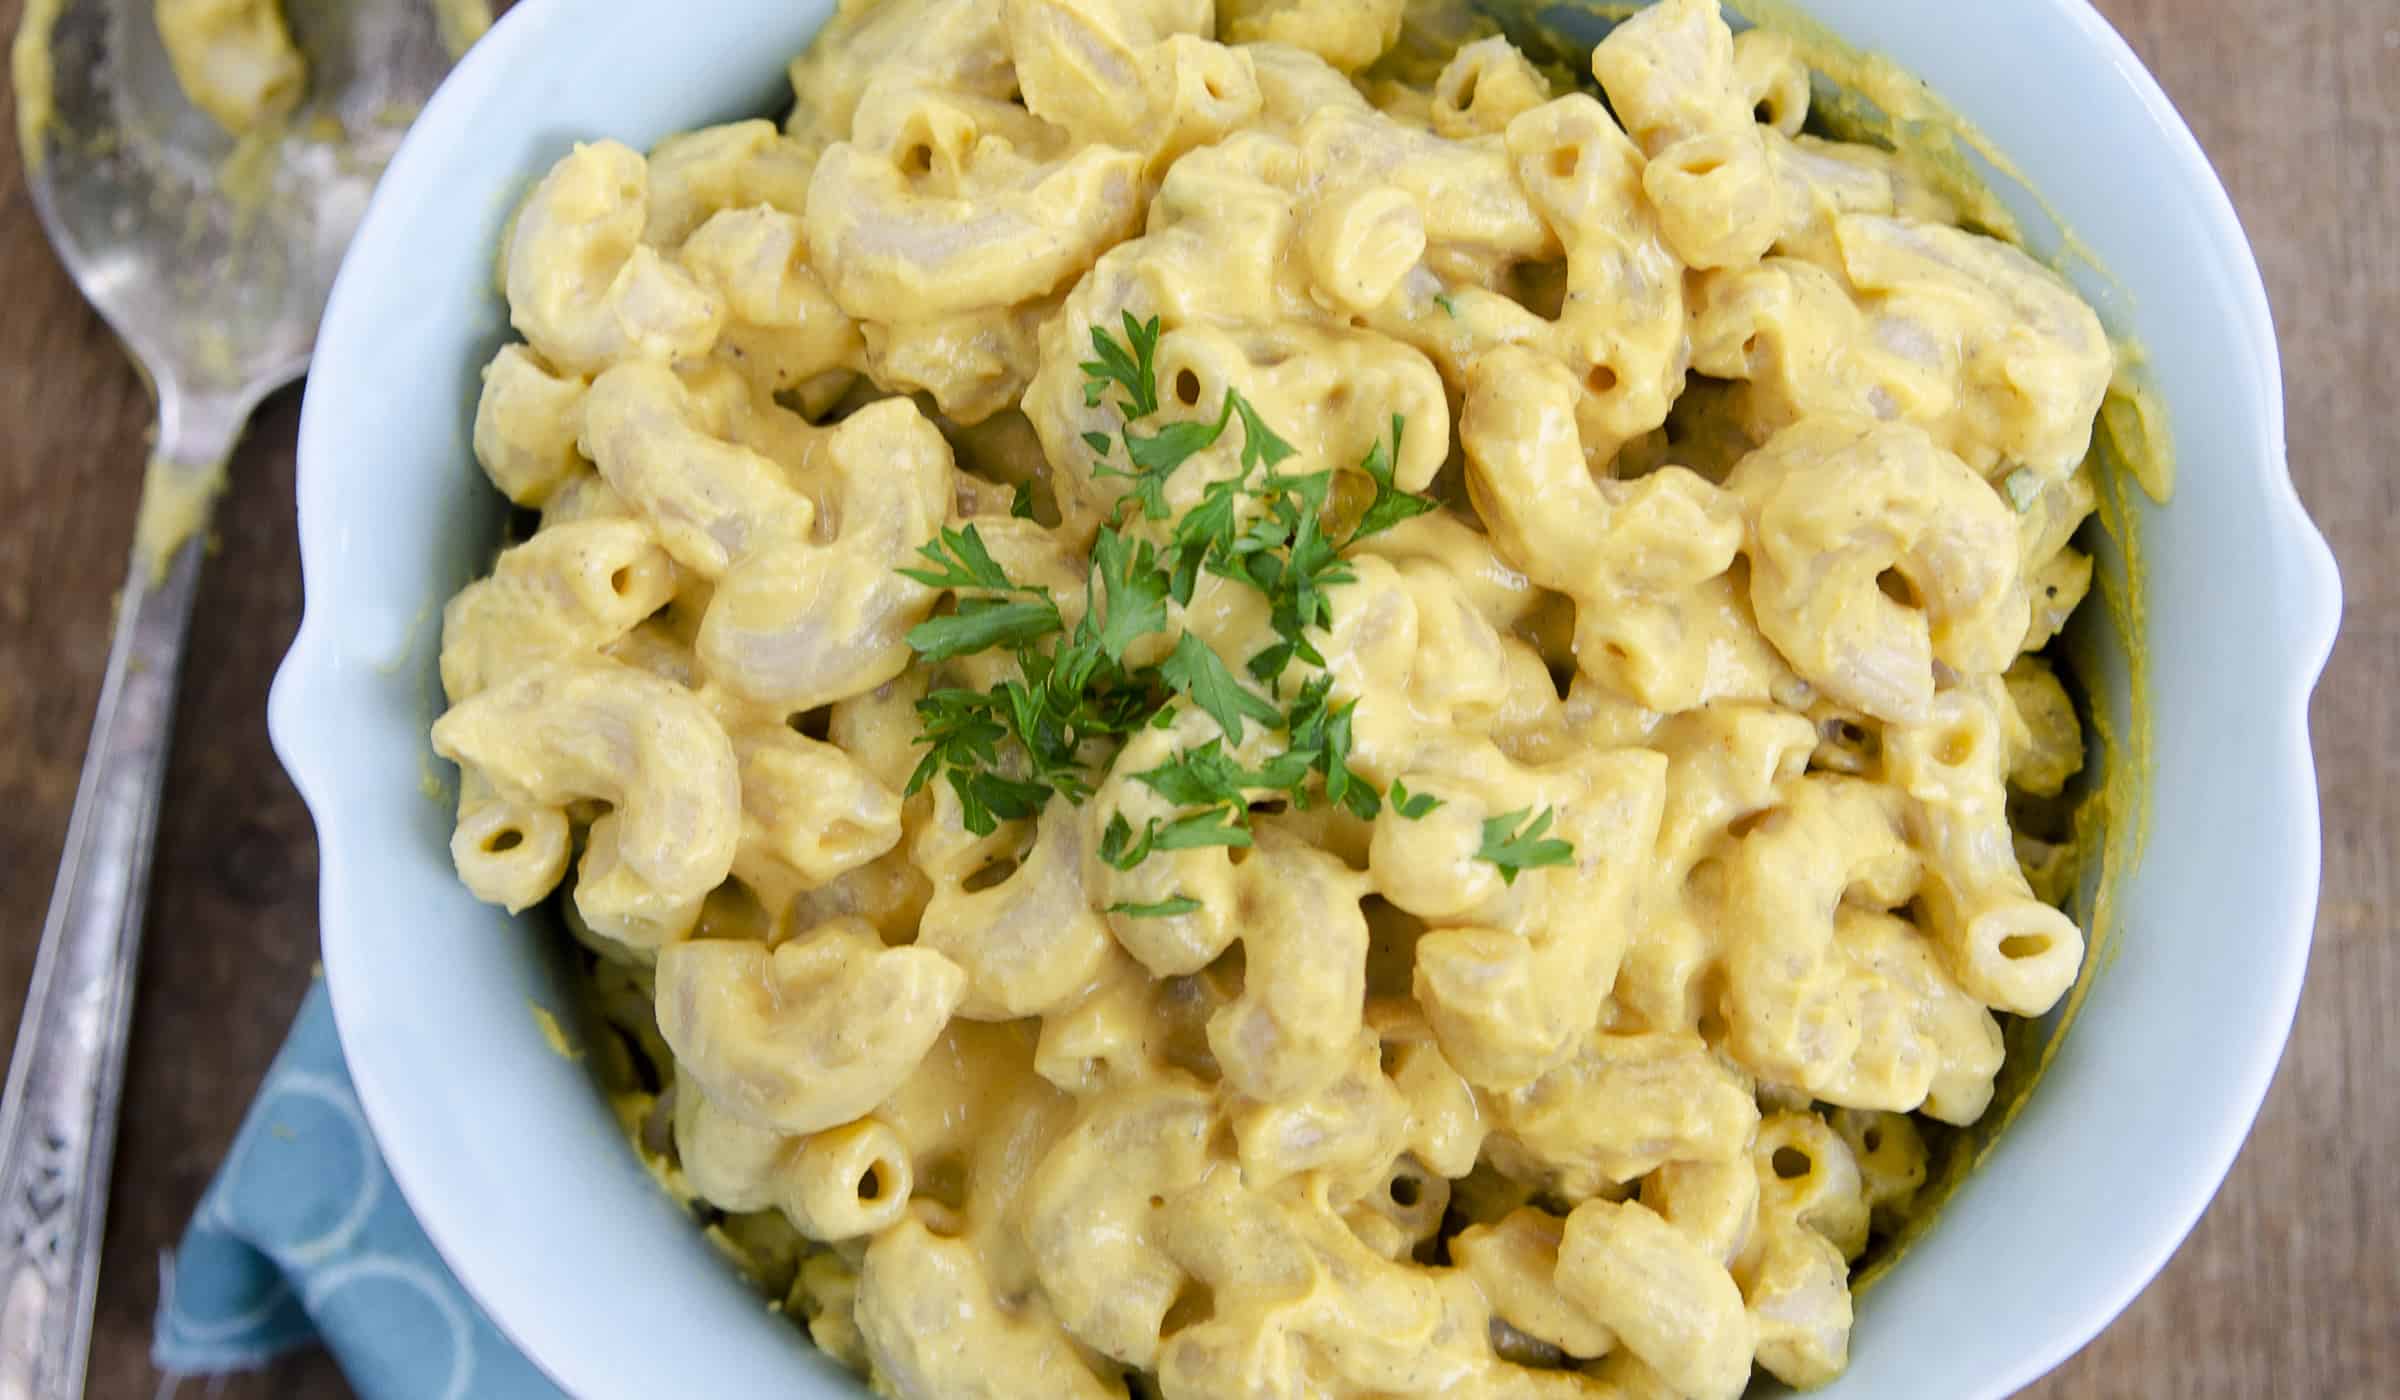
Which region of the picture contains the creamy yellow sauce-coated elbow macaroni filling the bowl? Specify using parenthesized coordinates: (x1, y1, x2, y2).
(436, 0, 2112, 1400)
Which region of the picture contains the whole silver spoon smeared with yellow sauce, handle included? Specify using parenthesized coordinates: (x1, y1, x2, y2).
(0, 0, 470, 1400)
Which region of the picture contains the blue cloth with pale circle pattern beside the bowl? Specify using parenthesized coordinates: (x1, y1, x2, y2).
(151, 982, 559, 1400)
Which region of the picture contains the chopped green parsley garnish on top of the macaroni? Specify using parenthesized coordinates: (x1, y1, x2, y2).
(902, 312, 1572, 888)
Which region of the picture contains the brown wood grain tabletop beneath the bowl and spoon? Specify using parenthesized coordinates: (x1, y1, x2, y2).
(0, 0, 2400, 1400)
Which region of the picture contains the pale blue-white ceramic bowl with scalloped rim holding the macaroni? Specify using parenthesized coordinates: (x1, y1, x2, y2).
(269, 0, 2340, 1400)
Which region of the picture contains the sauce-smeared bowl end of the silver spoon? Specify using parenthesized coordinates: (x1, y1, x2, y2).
(17, 0, 451, 449)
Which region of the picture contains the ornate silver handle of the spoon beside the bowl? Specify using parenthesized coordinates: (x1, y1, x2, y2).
(0, 494, 202, 1400)
